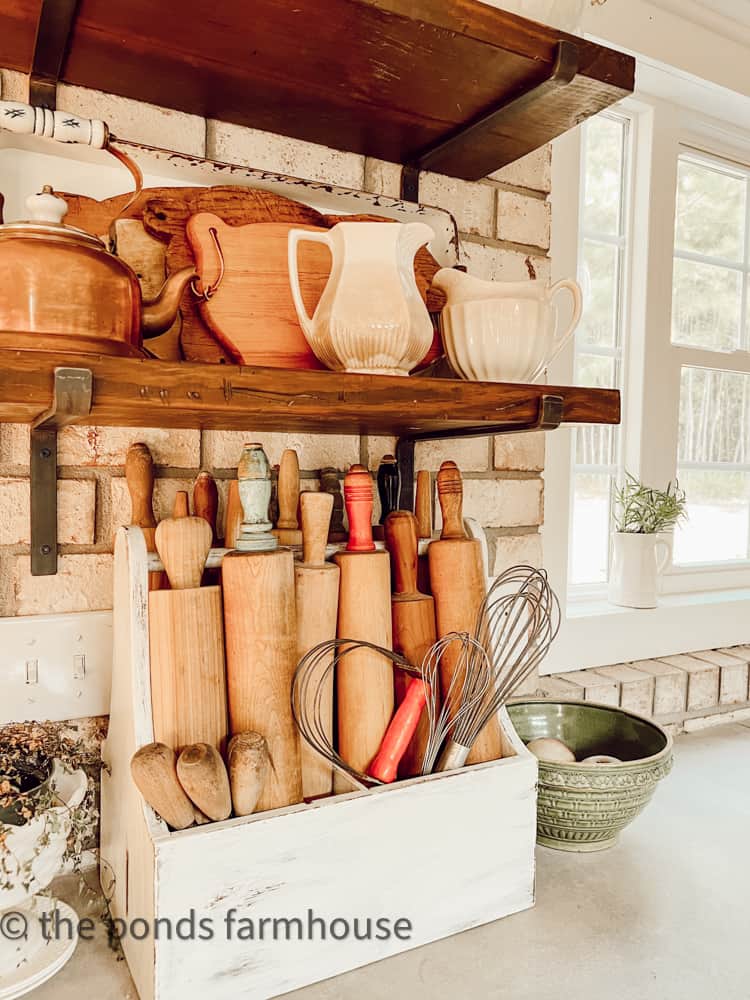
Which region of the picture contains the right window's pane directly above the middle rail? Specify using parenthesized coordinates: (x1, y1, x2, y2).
(672, 259, 742, 351)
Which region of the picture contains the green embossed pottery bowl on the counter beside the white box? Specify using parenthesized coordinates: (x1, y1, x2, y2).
(506, 698, 672, 851)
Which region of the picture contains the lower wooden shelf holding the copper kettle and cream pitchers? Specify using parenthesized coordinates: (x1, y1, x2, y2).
(0, 350, 620, 437)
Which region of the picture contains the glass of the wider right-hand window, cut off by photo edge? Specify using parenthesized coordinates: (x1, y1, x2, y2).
(671, 150, 750, 566)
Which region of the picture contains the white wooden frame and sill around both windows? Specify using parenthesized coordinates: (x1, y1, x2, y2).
(542, 95, 750, 674)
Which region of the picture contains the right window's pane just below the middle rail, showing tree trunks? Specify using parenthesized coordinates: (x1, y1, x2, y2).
(678, 367, 750, 464)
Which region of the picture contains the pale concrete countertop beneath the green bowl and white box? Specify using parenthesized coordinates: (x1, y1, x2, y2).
(29, 724, 750, 1000)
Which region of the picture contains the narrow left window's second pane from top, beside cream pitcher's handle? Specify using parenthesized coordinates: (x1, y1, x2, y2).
(576, 240, 619, 347)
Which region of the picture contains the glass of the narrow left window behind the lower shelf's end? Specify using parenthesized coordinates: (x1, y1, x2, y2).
(569, 114, 630, 587)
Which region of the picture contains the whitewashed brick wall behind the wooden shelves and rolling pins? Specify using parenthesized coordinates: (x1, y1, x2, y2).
(0, 70, 550, 617)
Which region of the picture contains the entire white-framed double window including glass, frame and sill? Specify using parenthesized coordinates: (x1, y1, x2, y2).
(544, 94, 750, 673)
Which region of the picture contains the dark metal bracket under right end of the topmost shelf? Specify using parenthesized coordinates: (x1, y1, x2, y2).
(401, 40, 580, 202)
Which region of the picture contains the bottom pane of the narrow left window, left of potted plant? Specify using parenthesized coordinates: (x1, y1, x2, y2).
(570, 473, 612, 584)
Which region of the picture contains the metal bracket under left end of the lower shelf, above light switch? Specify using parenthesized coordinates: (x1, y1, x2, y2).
(30, 368, 94, 576)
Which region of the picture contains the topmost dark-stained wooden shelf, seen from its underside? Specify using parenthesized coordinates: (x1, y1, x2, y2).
(0, 0, 635, 180)
